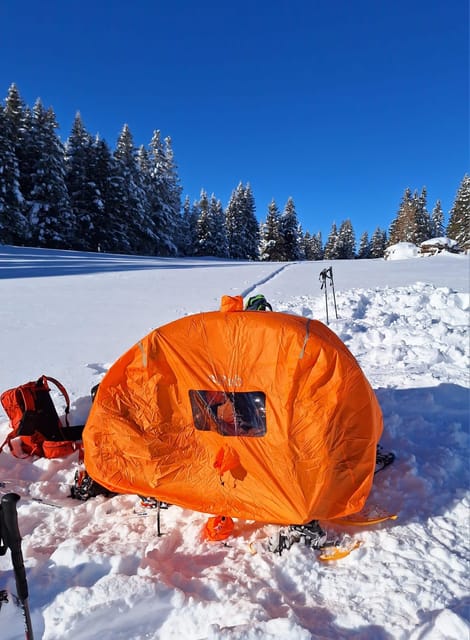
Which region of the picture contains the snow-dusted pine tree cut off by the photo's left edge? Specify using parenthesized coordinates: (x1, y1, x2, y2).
(0, 105, 27, 244)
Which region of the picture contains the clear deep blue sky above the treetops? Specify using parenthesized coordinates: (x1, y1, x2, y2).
(0, 0, 470, 240)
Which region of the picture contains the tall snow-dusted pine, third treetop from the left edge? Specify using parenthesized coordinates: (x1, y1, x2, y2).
(27, 99, 75, 248)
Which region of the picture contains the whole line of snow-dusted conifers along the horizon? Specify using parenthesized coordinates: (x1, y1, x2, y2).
(0, 84, 470, 261)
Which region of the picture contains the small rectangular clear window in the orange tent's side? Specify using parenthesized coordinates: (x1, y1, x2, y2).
(189, 389, 266, 438)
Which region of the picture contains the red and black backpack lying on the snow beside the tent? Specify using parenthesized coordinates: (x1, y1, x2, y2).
(0, 376, 84, 458)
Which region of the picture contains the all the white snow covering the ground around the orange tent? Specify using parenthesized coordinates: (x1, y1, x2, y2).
(0, 242, 470, 640)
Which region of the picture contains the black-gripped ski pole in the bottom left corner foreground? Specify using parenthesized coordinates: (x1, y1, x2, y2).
(0, 493, 33, 640)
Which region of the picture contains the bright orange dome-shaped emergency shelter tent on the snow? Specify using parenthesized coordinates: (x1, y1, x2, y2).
(83, 296, 382, 524)
